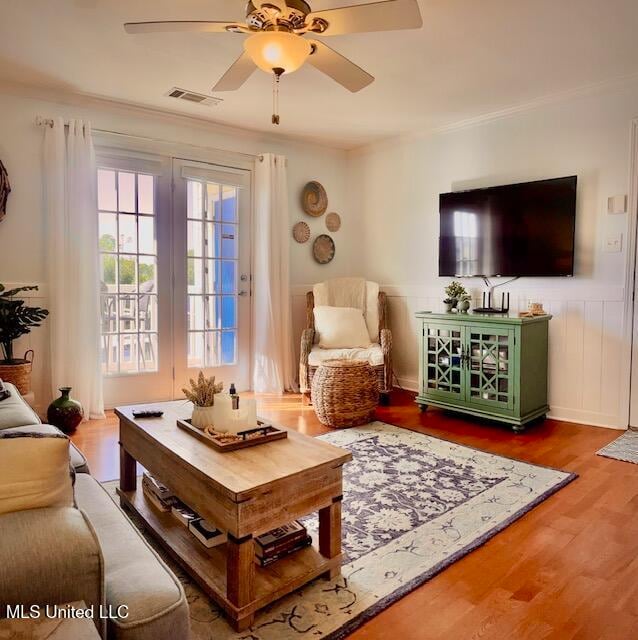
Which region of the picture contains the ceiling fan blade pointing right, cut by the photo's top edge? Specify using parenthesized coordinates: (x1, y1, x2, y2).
(306, 0, 423, 36)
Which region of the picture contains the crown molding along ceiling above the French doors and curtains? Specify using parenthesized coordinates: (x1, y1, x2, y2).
(0, 79, 347, 153)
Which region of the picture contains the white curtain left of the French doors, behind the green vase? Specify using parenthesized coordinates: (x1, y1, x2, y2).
(44, 118, 104, 419)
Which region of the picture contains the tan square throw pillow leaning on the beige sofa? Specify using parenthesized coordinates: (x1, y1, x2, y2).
(0, 429, 73, 514)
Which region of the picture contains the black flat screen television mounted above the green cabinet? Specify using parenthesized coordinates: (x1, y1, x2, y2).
(439, 176, 577, 277)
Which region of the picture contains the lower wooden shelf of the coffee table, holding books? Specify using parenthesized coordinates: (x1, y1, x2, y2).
(117, 478, 342, 628)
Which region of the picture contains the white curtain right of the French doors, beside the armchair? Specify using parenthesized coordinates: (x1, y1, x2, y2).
(252, 153, 297, 393)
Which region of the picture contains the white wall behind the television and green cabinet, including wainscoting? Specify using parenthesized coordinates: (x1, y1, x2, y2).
(349, 81, 638, 427)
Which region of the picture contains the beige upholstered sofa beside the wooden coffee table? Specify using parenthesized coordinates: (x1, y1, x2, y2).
(0, 385, 190, 640)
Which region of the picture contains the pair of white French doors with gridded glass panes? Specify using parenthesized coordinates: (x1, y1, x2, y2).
(98, 154, 251, 407)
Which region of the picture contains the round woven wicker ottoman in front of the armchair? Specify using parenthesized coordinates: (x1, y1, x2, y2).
(312, 360, 379, 428)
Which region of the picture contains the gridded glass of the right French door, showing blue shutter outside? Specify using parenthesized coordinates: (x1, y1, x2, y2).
(186, 178, 239, 368)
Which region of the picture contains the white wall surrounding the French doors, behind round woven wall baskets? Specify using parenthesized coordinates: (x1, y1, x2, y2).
(0, 86, 360, 408)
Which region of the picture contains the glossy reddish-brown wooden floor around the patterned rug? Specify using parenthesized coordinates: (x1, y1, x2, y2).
(73, 392, 638, 640)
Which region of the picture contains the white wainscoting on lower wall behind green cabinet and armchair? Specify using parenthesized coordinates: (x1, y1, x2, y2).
(293, 282, 630, 429)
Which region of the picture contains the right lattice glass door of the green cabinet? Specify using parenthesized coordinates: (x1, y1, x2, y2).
(466, 327, 514, 409)
